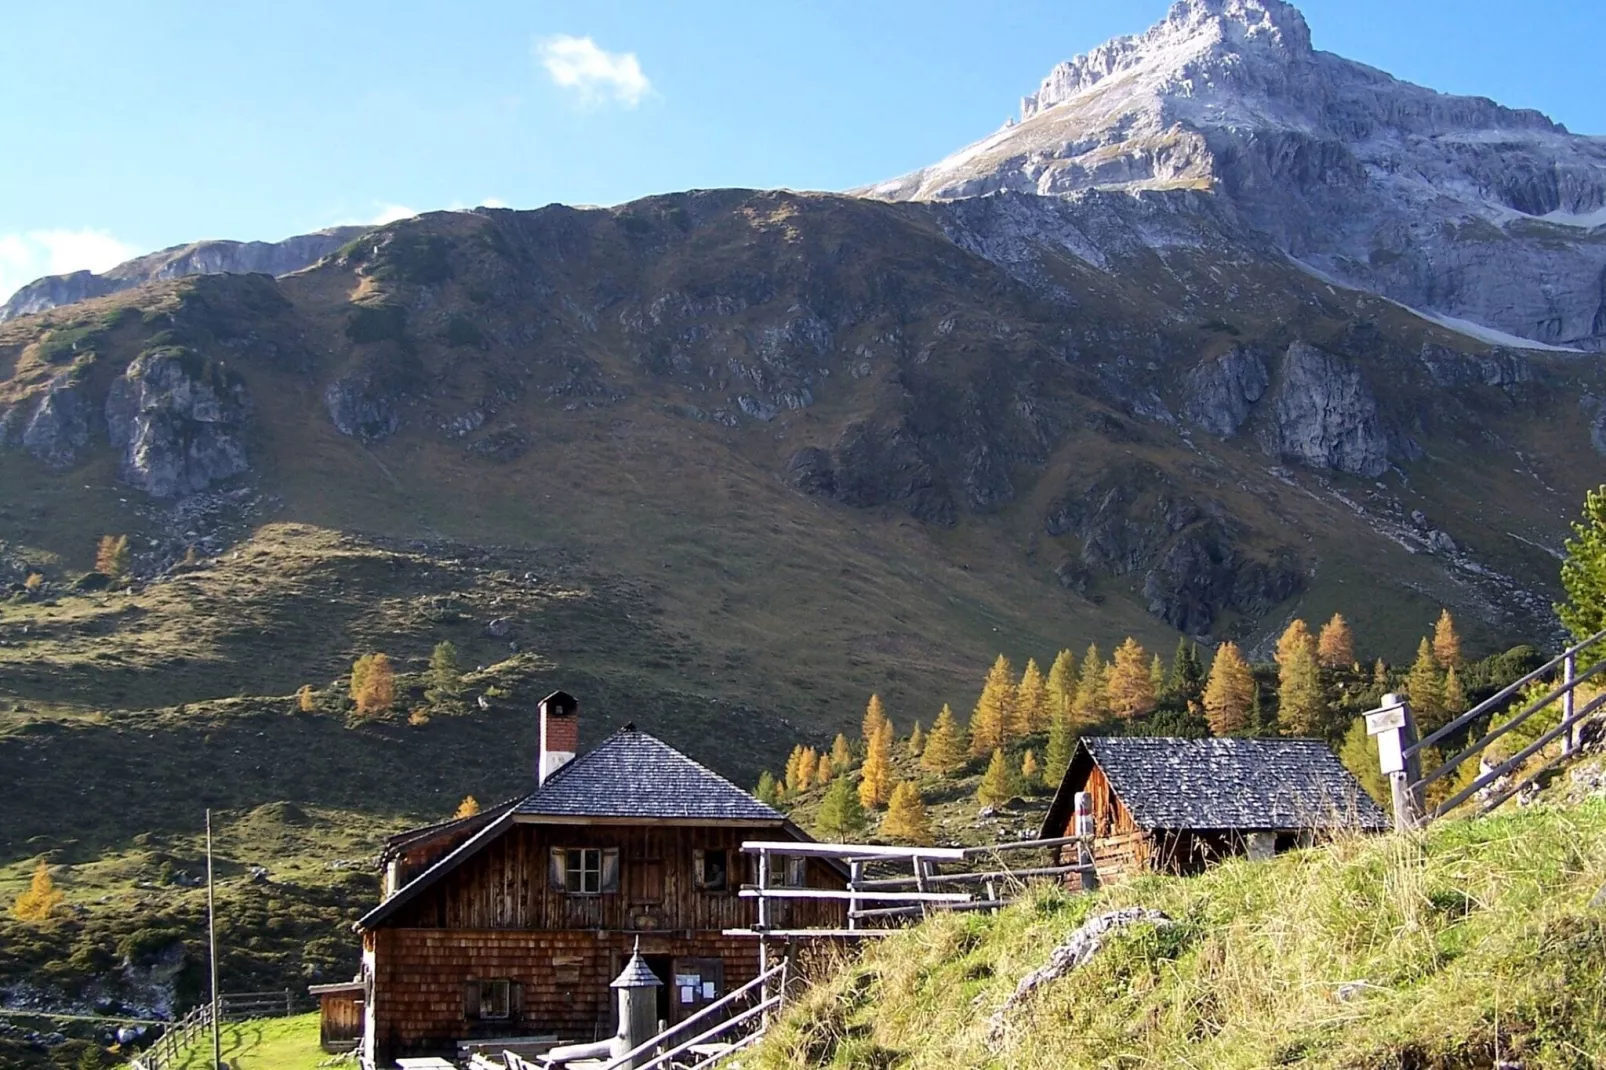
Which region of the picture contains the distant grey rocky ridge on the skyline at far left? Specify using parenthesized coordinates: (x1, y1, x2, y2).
(0, 227, 368, 323)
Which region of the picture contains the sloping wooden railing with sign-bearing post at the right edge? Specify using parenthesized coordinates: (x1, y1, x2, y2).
(1367, 631, 1606, 831)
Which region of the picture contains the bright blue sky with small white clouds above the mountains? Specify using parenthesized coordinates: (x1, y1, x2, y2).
(0, 0, 1606, 296)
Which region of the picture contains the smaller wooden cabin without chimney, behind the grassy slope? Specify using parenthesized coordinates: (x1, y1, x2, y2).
(1042, 736, 1392, 880)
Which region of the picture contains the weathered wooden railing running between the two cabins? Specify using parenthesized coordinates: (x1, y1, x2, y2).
(726, 829, 1099, 948)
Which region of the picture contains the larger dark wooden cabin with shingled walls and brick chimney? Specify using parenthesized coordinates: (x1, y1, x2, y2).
(340, 691, 846, 1067)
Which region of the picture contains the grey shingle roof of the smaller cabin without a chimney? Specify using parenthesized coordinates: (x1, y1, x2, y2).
(1044, 736, 1392, 835)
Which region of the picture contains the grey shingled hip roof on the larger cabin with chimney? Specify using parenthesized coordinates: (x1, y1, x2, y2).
(514, 725, 785, 823)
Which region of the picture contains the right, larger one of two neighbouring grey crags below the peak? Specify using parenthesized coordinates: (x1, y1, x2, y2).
(1261, 342, 1389, 476)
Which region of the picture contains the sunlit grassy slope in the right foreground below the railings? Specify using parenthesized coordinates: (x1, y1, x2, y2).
(755, 797, 1606, 1070)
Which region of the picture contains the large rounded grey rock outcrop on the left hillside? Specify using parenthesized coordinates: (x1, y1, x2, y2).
(106, 349, 251, 498)
